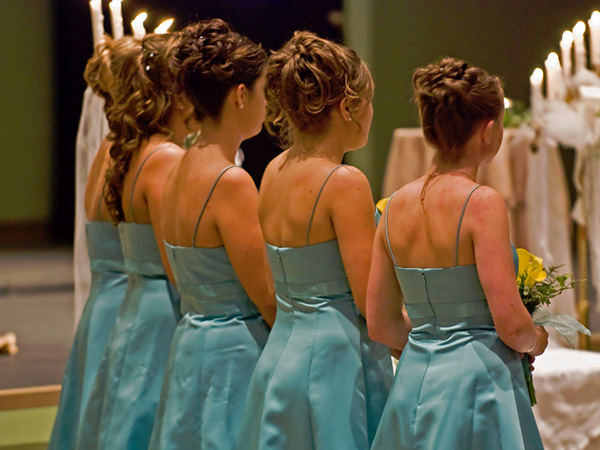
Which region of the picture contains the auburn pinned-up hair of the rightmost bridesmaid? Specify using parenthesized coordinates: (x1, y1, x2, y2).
(413, 58, 504, 164)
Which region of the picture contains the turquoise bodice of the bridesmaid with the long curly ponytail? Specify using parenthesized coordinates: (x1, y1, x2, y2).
(119, 222, 166, 278)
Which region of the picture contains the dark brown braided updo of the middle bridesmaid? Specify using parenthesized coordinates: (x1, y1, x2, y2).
(173, 19, 267, 121)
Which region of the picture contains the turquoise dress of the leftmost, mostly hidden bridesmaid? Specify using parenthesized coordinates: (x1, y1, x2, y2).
(48, 222, 127, 450)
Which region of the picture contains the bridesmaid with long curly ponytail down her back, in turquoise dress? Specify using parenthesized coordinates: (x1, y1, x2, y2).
(77, 35, 191, 450)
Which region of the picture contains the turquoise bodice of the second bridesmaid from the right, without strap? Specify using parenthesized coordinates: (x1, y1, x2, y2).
(267, 239, 352, 301)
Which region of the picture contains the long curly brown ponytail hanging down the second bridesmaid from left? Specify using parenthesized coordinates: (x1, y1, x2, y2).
(104, 33, 178, 222)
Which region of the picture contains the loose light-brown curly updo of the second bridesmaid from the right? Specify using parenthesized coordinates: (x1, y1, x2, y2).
(265, 31, 373, 147)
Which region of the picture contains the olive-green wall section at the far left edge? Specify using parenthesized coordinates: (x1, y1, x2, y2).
(0, 0, 53, 223)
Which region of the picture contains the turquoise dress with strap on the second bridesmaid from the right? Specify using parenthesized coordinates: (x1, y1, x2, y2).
(237, 166, 392, 450)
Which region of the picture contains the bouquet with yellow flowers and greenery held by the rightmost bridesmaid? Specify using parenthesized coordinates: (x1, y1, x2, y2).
(517, 248, 590, 406)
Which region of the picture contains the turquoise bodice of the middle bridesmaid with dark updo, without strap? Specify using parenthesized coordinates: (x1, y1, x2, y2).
(165, 242, 259, 316)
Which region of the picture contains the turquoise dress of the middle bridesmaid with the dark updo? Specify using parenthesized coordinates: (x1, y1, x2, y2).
(150, 166, 269, 450)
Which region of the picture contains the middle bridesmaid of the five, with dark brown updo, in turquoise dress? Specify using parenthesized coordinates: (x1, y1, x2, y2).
(150, 19, 275, 450)
